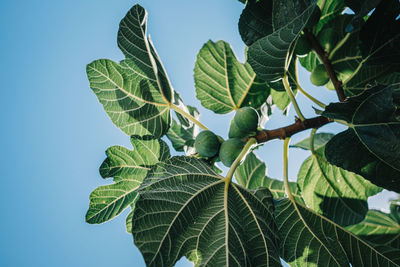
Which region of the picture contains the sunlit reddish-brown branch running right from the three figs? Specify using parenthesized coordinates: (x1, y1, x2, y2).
(254, 116, 333, 143)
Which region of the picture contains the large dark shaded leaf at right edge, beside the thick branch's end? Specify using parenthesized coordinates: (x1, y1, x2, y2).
(322, 86, 400, 192)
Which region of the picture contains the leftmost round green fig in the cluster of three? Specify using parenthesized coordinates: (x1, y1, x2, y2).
(194, 130, 221, 157)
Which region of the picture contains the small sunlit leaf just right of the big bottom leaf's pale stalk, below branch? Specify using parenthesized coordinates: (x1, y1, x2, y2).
(235, 152, 301, 198)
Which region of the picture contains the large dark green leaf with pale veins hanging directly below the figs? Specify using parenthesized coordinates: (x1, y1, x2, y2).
(133, 157, 281, 266)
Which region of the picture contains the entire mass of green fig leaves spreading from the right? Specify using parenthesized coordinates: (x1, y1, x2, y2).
(86, 0, 400, 267)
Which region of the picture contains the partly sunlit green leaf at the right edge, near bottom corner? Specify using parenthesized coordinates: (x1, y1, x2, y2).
(346, 210, 400, 249)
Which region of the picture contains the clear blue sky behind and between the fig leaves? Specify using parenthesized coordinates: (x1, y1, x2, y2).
(0, 0, 393, 267)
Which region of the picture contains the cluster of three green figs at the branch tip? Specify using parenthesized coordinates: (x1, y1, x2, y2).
(194, 107, 259, 167)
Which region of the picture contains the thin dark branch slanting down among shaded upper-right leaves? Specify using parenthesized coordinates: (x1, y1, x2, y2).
(304, 29, 346, 102)
